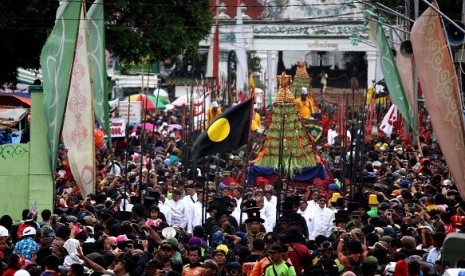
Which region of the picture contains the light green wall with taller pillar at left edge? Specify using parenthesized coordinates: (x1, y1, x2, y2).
(0, 86, 54, 220)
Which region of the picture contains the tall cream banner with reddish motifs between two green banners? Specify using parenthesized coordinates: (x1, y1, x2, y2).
(63, 5, 95, 197)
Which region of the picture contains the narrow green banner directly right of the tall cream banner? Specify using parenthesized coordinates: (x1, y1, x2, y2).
(87, 0, 111, 138)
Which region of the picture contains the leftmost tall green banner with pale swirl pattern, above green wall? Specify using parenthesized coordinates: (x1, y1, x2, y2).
(40, 1, 82, 173)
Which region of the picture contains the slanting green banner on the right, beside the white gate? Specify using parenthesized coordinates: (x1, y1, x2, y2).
(375, 23, 417, 132)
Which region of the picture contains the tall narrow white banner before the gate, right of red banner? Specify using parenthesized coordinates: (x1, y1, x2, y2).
(236, 0, 249, 93)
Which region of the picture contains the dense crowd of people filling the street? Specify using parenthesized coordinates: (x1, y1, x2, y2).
(0, 93, 465, 276)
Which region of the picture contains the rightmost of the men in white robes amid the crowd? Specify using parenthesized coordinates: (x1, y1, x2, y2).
(308, 195, 334, 240)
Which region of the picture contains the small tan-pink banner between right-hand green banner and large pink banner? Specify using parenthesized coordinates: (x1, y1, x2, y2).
(396, 48, 417, 124)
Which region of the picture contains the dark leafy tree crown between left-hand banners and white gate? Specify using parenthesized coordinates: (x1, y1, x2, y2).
(105, 0, 213, 66)
